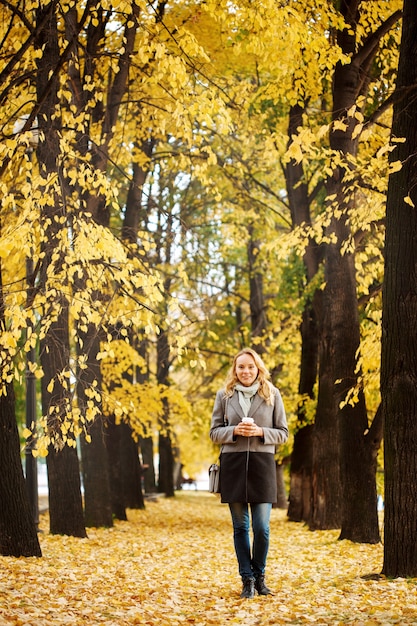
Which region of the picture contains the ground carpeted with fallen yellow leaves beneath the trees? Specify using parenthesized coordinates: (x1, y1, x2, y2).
(0, 491, 417, 626)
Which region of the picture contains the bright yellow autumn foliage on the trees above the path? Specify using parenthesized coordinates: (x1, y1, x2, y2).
(0, 0, 404, 463)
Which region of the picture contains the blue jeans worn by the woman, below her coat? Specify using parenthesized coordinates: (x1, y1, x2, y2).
(229, 502, 272, 578)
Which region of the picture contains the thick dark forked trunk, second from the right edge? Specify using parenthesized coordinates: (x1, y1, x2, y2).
(313, 0, 400, 543)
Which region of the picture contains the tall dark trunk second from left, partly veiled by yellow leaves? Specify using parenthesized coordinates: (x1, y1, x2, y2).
(36, 2, 86, 537)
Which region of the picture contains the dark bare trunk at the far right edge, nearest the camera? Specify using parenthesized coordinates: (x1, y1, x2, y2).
(381, 0, 417, 578)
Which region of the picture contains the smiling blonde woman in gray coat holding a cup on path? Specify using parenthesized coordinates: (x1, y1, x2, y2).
(210, 348, 288, 598)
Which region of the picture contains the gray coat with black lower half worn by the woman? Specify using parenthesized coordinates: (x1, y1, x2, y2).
(210, 387, 288, 502)
